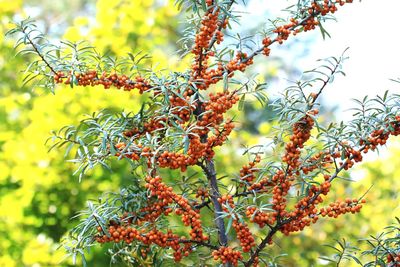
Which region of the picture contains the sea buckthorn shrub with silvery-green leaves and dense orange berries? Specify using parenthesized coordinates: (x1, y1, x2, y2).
(6, 0, 400, 267)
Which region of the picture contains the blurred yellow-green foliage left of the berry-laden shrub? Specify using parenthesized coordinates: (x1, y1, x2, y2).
(0, 0, 187, 267)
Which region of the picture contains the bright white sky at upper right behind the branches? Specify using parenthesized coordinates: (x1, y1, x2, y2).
(248, 0, 400, 112)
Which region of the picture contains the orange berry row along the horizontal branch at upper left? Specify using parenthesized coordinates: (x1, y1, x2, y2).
(54, 70, 151, 93)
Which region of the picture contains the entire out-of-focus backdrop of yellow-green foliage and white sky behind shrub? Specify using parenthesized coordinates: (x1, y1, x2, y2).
(0, 0, 400, 267)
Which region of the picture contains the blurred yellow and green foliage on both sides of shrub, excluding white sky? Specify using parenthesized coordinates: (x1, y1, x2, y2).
(0, 0, 400, 267)
